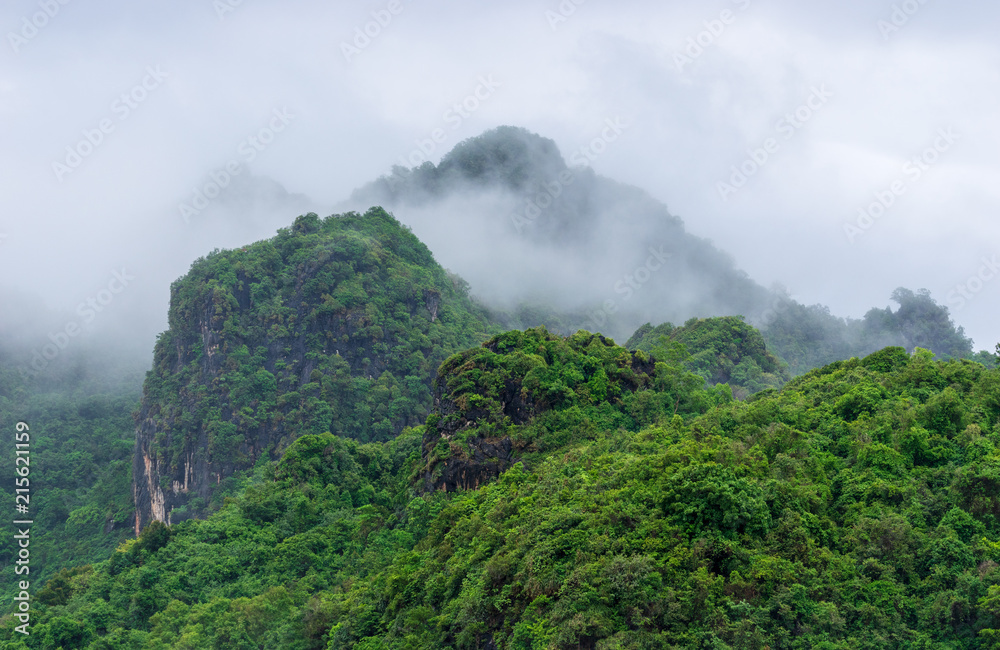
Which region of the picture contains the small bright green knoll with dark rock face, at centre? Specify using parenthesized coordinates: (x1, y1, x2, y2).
(423, 327, 732, 490)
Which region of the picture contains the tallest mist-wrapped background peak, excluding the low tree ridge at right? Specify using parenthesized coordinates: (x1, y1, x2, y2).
(345, 126, 770, 340)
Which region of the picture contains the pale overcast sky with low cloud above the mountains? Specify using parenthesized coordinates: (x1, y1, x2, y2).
(0, 0, 1000, 350)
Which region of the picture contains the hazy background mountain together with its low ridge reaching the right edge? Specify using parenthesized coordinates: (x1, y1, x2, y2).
(341, 126, 992, 368)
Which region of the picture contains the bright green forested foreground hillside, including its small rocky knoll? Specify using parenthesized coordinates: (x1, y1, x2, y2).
(3, 330, 1000, 648)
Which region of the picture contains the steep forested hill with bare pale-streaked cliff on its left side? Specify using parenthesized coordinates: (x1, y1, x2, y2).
(133, 208, 491, 534)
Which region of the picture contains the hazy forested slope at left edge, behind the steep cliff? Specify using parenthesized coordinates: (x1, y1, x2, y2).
(0, 349, 142, 611)
